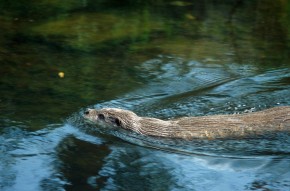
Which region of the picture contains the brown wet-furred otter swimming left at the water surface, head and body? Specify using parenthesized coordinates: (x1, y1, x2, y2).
(84, 106, 290, 140)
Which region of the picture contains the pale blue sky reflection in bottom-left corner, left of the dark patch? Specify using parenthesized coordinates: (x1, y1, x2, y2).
(0, 125, 102, 190)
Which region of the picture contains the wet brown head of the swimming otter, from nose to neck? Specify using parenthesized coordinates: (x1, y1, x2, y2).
(84, 108, 139, 131)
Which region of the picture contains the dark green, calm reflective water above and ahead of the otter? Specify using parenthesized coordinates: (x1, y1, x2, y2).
(0, 0, 290, 127)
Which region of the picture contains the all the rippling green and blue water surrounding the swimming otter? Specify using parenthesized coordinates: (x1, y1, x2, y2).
(0, 0, 290, 191)
